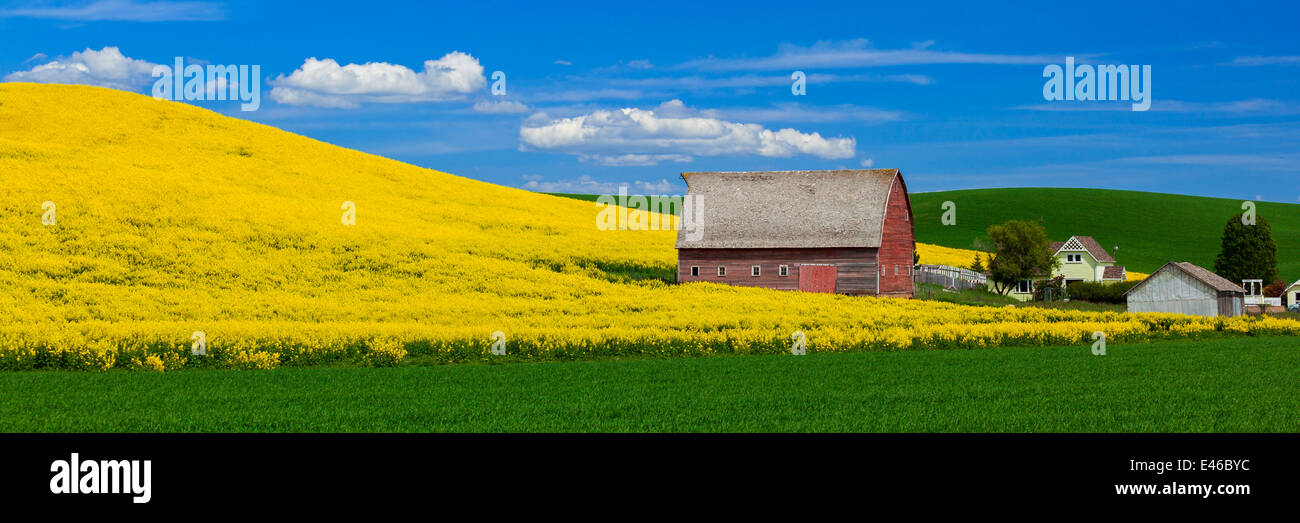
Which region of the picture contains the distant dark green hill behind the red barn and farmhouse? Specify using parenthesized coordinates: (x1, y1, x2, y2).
(556, 189, 1300, 278)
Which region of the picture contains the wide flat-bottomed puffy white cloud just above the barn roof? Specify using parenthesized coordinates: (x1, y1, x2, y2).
(519, 100, 857, 165)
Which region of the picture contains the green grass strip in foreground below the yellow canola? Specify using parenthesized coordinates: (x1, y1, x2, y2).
(0, 338, 1300, 432)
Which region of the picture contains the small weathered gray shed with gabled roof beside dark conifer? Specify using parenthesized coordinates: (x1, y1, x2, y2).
(1125, 262, 1245, 316)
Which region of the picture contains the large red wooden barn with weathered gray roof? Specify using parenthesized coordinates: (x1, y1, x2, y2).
(677, 169, 917, 298)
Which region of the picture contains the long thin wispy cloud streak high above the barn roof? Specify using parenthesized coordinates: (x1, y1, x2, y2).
(679, 39, 1055, 72)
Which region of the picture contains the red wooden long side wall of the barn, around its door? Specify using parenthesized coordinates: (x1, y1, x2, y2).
(677, 248, 878, 294)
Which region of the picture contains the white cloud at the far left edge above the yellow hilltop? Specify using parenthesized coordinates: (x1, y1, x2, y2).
(4, 47, 155, 91)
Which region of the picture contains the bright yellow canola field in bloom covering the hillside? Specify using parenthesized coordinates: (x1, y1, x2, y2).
(0, 83, 1279, 371)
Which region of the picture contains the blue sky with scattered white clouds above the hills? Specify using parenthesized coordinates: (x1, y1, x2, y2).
(0, 0, 1300, 203)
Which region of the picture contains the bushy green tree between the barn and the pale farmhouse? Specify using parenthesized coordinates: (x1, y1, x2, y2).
(988, 220, 1061, 294)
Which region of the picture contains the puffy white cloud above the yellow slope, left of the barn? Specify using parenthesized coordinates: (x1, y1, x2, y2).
(270, 51, 488, 108)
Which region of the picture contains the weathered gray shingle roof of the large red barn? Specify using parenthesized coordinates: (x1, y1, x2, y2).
(677, 169, 900, 248)
